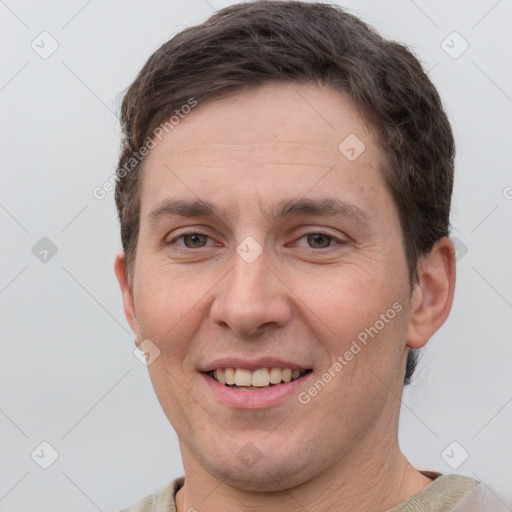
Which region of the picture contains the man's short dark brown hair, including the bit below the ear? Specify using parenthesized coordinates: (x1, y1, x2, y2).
(116, 0, 455, 383)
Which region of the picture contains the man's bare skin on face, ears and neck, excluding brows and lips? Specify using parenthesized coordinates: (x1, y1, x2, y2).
(115, 84, 455, 512)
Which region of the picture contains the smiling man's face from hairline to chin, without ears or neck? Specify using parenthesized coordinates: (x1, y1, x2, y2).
(119, 84, 420, 490)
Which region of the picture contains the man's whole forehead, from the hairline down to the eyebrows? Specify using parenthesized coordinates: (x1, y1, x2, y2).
(141, 84, 385, 220)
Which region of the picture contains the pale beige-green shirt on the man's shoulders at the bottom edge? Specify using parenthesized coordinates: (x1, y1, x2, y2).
(120, 471, 510, 512)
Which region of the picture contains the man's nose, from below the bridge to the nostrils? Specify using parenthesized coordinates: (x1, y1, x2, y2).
(210, 247, 292, 337)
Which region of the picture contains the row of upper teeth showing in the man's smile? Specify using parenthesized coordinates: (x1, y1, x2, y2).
(210, 368, 307, 388)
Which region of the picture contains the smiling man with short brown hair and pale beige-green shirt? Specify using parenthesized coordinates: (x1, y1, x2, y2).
(111, 1, 499, 512)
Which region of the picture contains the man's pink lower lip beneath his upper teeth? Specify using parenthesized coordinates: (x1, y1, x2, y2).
(201, 372, 311, 409)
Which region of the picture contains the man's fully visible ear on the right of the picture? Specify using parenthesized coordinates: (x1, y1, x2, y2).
(407, 237, 455, 348)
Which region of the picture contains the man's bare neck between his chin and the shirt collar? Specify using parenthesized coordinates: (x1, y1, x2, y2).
(176, 430, 431, 512)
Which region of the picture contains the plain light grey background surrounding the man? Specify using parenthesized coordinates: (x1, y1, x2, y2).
(0, 0, 512, 512)
